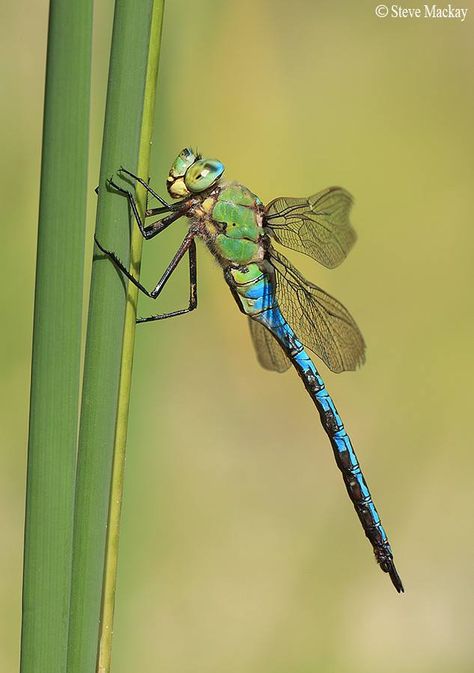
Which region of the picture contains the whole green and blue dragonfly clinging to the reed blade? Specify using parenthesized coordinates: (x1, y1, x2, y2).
(95, 147, 404, 593)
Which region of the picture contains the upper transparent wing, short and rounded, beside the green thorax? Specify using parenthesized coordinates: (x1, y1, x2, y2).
(265, 187, 356, 269)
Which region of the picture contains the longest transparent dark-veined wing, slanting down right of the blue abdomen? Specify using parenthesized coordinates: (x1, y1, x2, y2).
(269, 248, 365, 372)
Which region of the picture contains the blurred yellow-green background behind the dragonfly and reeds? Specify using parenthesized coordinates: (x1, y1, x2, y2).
(0, 0, 474, 673)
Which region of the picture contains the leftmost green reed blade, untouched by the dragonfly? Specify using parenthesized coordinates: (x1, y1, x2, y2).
(21, 0, 92, 673)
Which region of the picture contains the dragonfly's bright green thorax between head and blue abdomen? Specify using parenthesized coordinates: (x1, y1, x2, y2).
(192, 182, 264, 267)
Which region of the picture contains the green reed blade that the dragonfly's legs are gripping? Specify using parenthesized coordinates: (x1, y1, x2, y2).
(68, 0, 167, 673)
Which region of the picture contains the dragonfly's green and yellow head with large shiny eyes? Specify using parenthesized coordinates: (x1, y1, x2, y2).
(166, 147, 224, 199)
